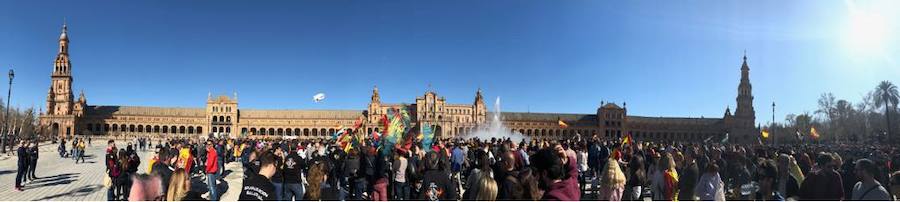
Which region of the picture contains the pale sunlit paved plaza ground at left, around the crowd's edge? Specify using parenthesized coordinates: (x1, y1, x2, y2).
(0, 139, 243, 201)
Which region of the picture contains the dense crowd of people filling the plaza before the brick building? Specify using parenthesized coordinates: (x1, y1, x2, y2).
(86, 133, 900, 201)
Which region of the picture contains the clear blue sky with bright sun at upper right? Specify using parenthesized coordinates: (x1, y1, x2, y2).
(0, 0, 900, 123)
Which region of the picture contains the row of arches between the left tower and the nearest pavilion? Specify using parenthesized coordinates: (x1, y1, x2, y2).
(85, 123, 203, 134)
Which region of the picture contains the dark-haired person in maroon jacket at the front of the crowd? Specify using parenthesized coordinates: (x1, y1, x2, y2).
(529, 144, 581, 201)
